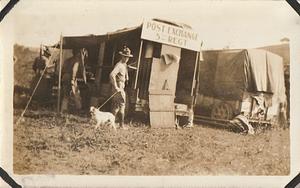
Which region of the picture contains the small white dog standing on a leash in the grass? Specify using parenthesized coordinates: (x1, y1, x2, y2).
(90, 106, 116, 130)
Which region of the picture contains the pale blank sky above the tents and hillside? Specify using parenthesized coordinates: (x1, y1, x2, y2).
(3, 0, 300, 49)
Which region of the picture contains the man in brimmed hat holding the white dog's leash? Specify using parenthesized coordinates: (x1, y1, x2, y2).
(110, 46, 133, 129)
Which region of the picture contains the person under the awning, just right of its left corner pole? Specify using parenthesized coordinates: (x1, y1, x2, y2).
(61, 48, 87, 112)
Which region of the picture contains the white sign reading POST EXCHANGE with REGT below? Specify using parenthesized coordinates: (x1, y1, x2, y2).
(141, 20, 201, 51)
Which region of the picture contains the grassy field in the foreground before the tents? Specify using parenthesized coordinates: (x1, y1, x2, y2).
(13, 110, 290, 175)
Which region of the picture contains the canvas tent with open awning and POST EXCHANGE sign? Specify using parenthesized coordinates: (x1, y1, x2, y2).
(50, 19, 200, 126)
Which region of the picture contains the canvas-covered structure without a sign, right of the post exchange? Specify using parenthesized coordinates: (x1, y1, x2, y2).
(195, 49, 286, 122)
